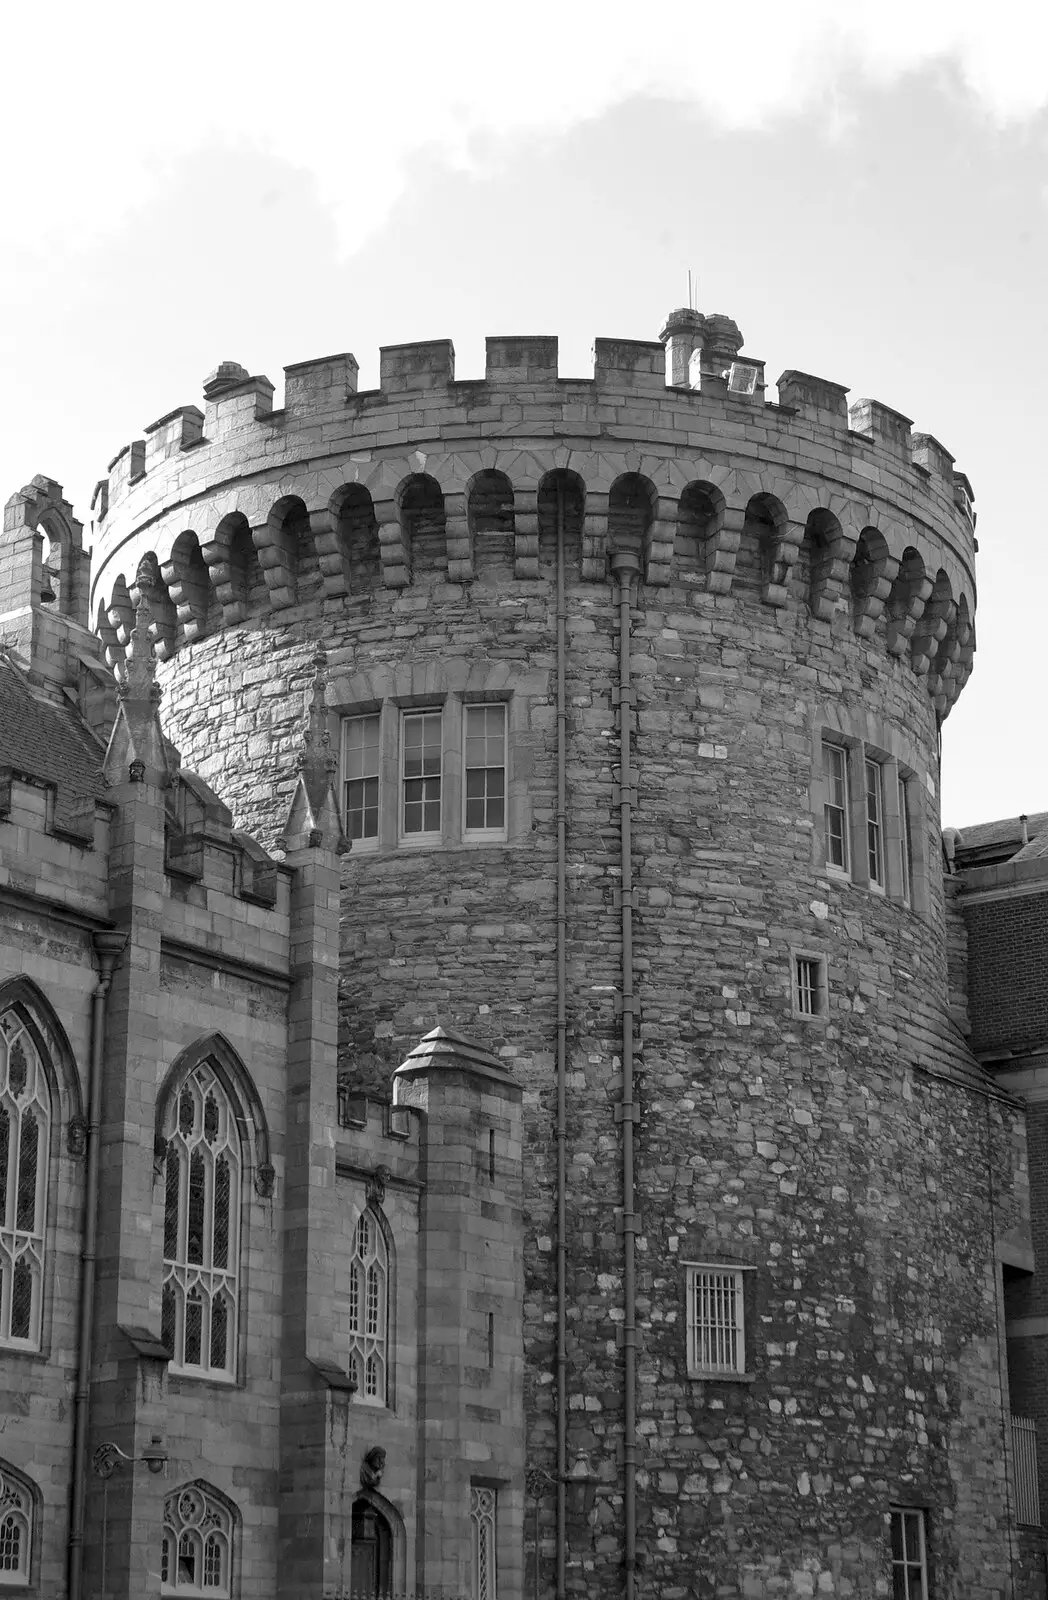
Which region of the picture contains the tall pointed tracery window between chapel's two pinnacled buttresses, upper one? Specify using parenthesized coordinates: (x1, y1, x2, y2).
(160, 1061, 243, 1379)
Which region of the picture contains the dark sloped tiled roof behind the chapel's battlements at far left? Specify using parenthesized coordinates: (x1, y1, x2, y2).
(0, 651, 106, 837)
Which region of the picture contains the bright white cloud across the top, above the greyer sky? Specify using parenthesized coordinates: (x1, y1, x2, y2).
(3, 0, 1048, 261)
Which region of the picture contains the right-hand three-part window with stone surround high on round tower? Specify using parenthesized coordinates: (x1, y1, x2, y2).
(810, 704, 934, 918)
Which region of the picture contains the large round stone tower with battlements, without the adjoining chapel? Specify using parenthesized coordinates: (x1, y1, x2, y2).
(91, 310, 1011, 1600)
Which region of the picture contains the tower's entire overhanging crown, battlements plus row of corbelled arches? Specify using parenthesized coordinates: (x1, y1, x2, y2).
(91, 309, 974, 715)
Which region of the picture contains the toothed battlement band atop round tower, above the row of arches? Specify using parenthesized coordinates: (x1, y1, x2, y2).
(91, 318, 971, 556)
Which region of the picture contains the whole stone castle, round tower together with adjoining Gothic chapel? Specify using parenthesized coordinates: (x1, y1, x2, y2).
(0, 310, 1048, 1600)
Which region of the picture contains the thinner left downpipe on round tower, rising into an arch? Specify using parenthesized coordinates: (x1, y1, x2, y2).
(553, 480, 568, 1600)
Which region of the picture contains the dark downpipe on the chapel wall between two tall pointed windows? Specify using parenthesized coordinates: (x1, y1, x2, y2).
(69, 933, 125, 1600)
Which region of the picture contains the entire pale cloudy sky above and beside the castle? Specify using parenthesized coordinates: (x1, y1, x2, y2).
(0, 0, 1048, 826)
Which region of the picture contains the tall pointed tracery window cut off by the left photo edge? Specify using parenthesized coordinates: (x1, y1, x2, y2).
(0, 1006, 51, 1350)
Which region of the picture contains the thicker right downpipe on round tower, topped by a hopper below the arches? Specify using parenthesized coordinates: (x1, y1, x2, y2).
(611, 550, 640, 1600)
